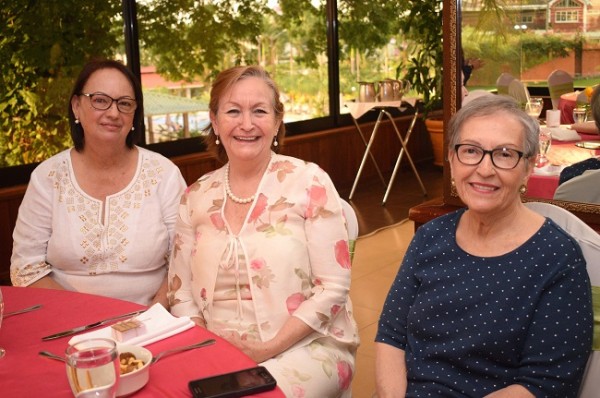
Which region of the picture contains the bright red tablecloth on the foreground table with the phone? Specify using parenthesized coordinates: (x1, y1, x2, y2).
(0, 286, 284, 398)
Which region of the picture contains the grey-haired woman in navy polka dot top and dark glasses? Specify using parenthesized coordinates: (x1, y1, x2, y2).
(376, 96, 593, 398)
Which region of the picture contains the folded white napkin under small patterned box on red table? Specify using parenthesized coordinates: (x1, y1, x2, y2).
(69, 304, 194, 346)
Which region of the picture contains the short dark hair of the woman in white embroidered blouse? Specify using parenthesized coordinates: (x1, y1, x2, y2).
(69, 59, 144, 151)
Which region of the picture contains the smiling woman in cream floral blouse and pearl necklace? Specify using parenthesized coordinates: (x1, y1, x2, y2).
(169, 66, 358, 397)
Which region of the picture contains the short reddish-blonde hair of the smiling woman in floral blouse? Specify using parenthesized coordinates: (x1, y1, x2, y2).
(204, 65, 285, 163)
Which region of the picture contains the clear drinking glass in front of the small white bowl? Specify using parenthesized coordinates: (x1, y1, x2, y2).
(66, 338, 119, 398)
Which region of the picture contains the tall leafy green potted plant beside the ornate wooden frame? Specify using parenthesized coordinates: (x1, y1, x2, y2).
(396, 0, 444, 166)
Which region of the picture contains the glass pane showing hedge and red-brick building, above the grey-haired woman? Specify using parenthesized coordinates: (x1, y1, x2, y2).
(461, 0, 600, 93)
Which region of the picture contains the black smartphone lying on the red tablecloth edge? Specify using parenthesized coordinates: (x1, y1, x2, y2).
(188, 366, 277, 398)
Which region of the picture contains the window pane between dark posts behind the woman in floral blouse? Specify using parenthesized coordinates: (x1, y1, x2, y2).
(138, 0, 329, 143)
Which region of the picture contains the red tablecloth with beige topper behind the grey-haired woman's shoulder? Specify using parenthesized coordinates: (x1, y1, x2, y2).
(527, 134, 600, 199)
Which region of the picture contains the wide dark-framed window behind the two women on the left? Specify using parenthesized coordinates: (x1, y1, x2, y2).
(0, 0, 407, 186)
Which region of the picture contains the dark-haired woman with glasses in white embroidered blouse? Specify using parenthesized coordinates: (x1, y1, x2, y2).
(11, 60, 185, 306)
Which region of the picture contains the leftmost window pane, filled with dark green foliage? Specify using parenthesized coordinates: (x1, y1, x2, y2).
(0, 0, 125, 167)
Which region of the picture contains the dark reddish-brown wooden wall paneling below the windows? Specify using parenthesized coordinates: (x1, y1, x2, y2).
(0, 116, 432, 285)
